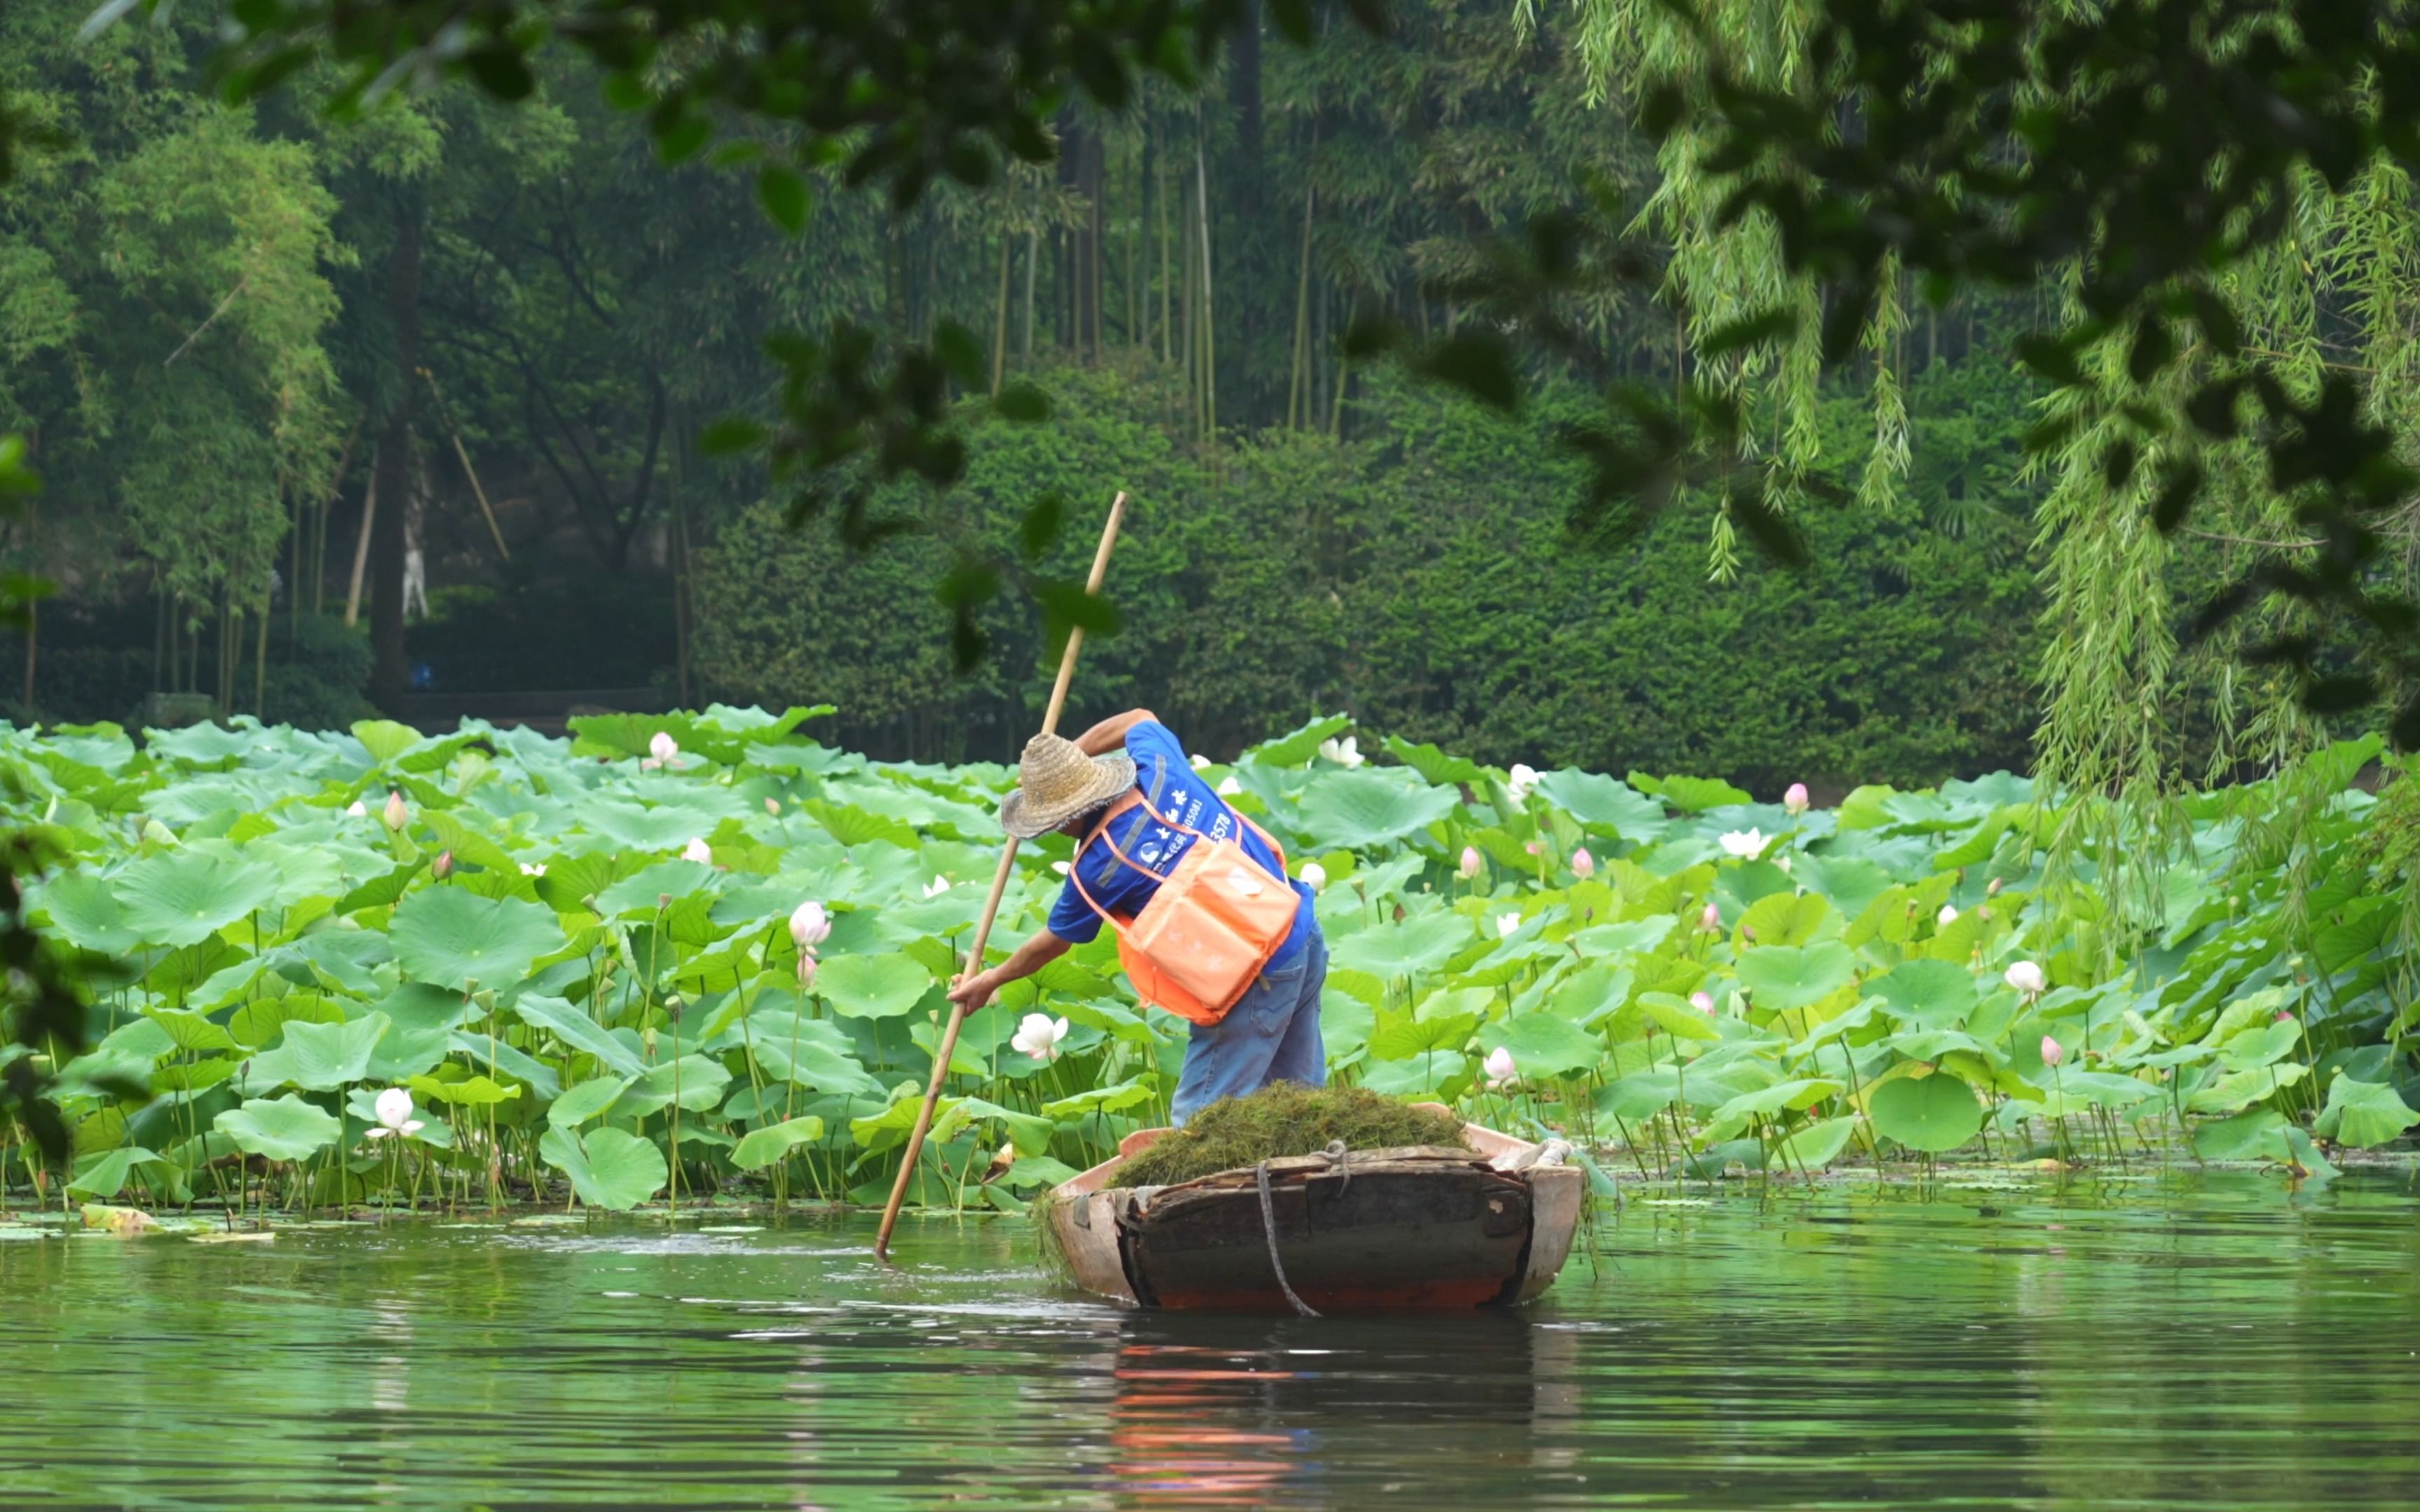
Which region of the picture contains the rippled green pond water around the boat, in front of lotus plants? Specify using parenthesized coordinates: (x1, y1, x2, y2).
(0, 1171, 2420, 1510)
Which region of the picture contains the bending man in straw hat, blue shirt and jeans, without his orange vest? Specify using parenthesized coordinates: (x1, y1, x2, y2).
(949, 709, 1328, 1125)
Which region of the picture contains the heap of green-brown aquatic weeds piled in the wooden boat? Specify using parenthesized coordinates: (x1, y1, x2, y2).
(1115, 1082, 1461, 1185)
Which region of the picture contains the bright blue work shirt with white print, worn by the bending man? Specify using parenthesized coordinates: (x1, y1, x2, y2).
(1050, 718, 1319, 970)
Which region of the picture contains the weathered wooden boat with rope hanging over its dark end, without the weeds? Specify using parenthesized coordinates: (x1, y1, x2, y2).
(1045, 1102, 1585, 1314)
